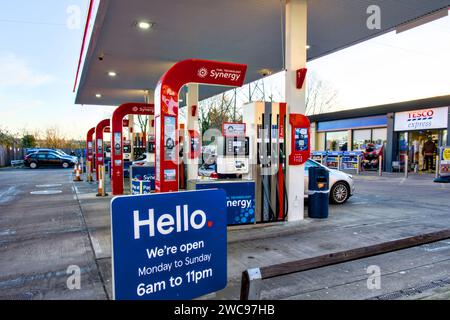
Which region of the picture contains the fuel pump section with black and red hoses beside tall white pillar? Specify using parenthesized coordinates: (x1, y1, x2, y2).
(243, 102, 288, 222)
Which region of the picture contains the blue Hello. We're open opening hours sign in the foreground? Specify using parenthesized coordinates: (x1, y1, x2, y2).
(111, 189, 227, 300)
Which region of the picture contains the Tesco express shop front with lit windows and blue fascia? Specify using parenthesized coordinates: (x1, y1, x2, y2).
(310, 96, 450, 172)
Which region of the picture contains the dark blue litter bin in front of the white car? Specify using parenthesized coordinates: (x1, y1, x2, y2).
(308, 167, 330, 219)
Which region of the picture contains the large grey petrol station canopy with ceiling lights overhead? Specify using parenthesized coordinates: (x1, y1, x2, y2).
(75, 0, 450, 105)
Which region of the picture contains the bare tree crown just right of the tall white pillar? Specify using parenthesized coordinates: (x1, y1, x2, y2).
(305, 74, 338, 115)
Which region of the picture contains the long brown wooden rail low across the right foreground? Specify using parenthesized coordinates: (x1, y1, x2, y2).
(260, 229, 450, 279)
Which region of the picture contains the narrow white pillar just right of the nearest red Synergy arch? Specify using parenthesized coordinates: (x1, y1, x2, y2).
(184, 84, 200, 180)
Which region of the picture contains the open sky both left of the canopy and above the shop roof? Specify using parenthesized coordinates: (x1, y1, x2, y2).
(0, 0, 450, 139)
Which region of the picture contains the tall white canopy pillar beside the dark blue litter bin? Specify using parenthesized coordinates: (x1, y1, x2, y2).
(285, 0, 308, 221)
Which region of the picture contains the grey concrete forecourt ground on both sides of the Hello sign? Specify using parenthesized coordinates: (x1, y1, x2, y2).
(0, 170, 450, 299)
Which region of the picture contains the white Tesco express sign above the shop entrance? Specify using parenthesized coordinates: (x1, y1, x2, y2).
(395, 107, 448, 131)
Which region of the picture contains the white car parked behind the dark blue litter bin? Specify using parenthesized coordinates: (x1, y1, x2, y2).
(305, 159, 355, 204)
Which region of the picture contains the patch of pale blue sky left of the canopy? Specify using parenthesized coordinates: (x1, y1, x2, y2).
(0, 0, 113, 139)
